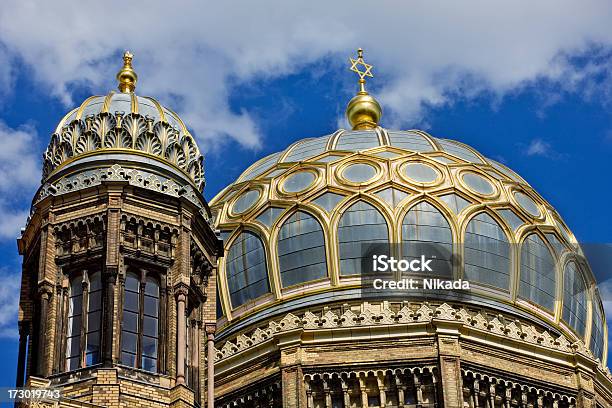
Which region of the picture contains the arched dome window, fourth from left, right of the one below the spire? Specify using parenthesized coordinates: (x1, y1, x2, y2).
(402, 201, 453, 277)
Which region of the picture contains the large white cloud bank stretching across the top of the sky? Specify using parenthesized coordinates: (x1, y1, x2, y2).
(0, 0, 612, 149)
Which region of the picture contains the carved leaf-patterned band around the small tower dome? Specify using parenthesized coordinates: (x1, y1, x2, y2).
(43, 112, 204, 190)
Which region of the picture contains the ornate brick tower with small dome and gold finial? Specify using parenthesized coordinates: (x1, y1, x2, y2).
(17, 52, 221, 407)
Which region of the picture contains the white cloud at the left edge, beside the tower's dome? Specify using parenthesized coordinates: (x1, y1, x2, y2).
(0, 121, 41, 240)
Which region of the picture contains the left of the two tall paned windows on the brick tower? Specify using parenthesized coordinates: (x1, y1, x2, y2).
(65, 272, 102, 371)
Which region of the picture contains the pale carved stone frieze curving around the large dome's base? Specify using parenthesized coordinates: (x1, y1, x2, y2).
(215, 303, 595, 362)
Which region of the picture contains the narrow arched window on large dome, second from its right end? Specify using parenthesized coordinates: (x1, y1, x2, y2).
(563, 262, 587, 336)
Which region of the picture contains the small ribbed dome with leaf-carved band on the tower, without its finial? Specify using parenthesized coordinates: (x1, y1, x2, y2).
(43, 92, 204, 190)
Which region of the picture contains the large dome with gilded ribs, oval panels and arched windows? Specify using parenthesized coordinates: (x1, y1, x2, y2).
(211, 127, 607, 360)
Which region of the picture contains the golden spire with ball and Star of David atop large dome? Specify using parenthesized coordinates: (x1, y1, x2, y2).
(346, 48, 382, 130)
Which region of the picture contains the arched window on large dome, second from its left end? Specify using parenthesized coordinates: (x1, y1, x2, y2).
(278, 211, 327, 287)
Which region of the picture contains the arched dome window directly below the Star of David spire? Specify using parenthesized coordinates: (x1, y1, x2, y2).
(338, 201, 389, 275)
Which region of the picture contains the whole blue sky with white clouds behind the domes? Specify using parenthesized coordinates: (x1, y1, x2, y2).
(0, 0, 612, 382)
